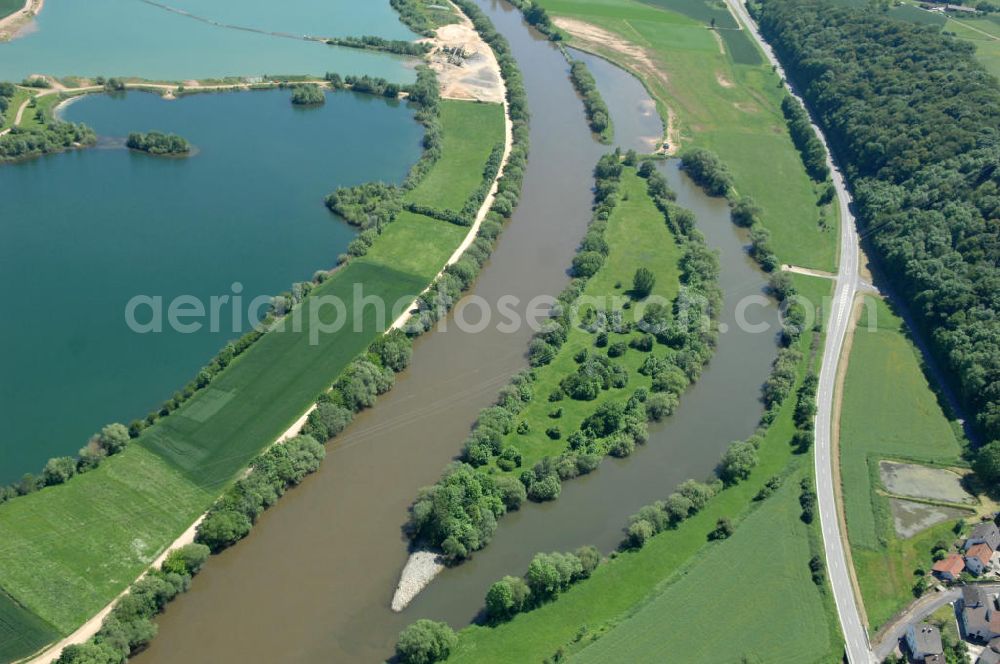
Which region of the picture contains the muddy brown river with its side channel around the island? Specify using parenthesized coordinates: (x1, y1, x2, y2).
(135, 0, 777, 664)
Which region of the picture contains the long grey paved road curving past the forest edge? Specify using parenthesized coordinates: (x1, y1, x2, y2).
(726, 0, 875, 664)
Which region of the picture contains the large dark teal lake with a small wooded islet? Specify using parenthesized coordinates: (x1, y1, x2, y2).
(0, 89, 423, 482)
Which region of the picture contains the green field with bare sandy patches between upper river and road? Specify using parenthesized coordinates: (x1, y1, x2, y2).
(541, 0, 838, 271)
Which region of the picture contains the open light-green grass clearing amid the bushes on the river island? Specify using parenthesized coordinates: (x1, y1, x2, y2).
(491, 168, 682, 474)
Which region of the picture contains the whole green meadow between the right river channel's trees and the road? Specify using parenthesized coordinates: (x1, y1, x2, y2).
(448, 275, 842, 664)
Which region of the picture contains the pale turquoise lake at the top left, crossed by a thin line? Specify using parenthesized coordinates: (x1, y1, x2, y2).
(0, 0, 416, 82)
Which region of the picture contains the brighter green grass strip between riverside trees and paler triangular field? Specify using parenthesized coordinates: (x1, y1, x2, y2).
(448, 275, 839, 663)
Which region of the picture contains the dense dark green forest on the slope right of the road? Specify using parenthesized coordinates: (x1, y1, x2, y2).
(754, 0, 1000, 452)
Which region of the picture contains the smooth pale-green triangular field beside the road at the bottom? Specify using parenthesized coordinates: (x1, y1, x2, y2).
(573, 466, 839, 664)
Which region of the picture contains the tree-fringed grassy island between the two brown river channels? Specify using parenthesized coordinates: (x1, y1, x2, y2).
(408, 158, 720, 562)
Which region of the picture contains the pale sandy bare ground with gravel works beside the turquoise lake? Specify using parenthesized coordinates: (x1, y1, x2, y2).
(425, 7, 504, 103)
